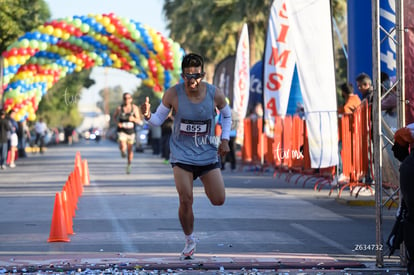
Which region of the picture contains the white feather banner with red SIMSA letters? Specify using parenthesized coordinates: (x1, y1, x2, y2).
(263, 0, 296, 137)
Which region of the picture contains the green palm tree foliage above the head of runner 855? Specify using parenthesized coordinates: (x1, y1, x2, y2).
(163, 0, 272, 67)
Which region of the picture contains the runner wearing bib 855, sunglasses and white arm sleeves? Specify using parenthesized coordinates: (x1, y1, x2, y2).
(141, 53, 231, 259)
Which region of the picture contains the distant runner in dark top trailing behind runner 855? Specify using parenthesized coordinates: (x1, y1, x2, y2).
(113, 93, 142, 174)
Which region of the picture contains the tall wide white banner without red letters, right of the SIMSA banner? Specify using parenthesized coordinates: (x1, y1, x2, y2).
(286, 0, 338, 168)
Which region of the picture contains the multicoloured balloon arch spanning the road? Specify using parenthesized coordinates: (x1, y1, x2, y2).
(2, 13, 184, 121)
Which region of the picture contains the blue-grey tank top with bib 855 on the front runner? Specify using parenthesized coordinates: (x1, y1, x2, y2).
(170, 83, 219, 166)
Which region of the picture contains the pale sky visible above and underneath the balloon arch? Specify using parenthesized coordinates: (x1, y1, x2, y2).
(45, 0, 169, 111)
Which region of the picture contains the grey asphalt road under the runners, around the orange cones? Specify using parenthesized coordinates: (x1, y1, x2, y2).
(0, 140, 408, 274)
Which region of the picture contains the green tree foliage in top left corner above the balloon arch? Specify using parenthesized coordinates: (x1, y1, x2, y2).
(0, 0, 50, 52)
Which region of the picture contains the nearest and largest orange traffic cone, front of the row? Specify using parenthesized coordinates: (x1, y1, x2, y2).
(47, 192, 70, 242)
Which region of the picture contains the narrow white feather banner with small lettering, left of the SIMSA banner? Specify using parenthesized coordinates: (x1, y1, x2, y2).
(233, 23, 250, 145)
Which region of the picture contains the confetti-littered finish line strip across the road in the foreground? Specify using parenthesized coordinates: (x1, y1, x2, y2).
(0, 253, 367, 274)
